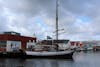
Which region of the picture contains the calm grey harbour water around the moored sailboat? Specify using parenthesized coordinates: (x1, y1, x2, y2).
(0, 52, 100, 67)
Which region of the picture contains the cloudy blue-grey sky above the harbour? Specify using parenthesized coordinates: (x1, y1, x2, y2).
(0, 0, 100, 41)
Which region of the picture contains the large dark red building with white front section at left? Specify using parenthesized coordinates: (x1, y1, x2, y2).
(0, 32, 36, 51)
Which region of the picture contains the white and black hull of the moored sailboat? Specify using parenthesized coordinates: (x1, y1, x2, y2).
(26, 51, 74, 59)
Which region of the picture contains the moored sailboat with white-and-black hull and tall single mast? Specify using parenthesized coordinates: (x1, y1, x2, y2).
(25, 0, 74, 59)
